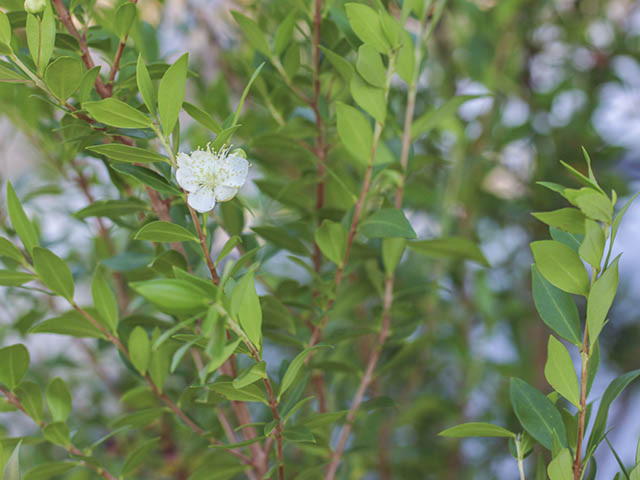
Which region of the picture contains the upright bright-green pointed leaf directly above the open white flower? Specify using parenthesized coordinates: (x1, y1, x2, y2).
(158, 53, 189, 136)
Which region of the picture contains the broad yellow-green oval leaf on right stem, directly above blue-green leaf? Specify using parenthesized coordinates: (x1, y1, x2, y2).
(531, 240, 589, 297)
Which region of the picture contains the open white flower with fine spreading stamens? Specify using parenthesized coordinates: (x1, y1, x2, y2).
(176, 145, 249, 213)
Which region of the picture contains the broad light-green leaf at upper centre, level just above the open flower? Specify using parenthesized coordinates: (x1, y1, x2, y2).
(336, 102, 373, 165)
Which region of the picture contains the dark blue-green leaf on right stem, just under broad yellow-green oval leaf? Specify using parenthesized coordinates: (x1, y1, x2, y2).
(531, 264, 582, 346)
